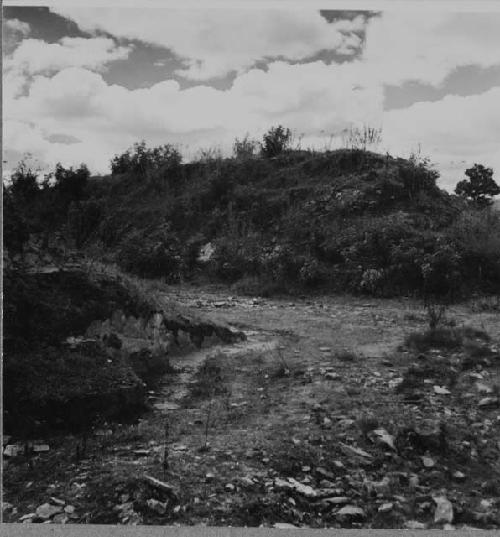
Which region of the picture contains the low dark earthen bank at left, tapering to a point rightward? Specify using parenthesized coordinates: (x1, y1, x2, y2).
(4, 267, 244, 435)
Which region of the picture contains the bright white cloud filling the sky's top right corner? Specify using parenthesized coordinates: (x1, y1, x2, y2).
(363, 11, 500, 85)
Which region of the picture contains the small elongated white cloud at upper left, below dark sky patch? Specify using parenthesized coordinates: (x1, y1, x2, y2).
(4, 37, 130, 75)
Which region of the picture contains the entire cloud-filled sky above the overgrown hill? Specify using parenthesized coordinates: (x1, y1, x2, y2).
(3, 2, 500, 189)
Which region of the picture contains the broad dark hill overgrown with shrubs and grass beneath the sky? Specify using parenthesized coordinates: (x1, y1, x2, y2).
(5, 129, 500, 297)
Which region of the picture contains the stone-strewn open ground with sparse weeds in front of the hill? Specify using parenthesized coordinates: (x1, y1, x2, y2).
(3, 287, 500, 529)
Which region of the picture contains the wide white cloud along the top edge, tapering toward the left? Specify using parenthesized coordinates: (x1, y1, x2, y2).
(51, 7, 365, 80)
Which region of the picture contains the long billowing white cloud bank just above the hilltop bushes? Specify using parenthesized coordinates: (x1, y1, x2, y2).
(5, 62, 383, 171)
